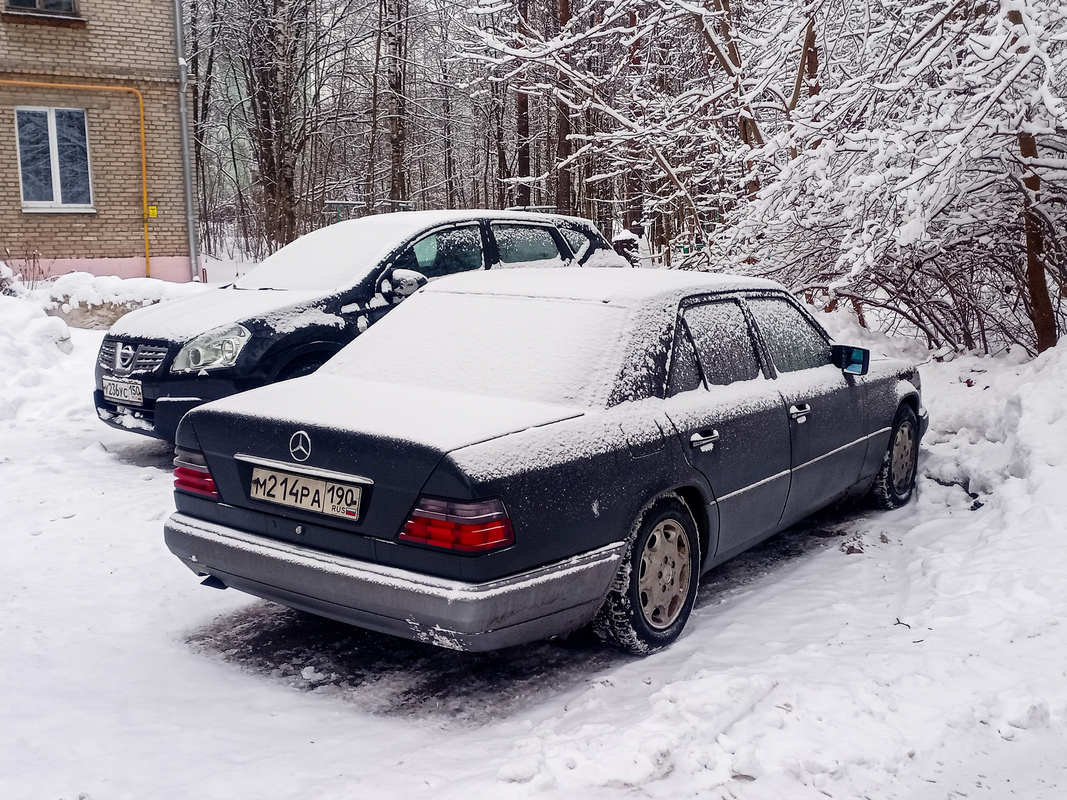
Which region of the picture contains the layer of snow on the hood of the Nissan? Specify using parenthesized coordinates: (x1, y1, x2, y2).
(110, 289, 321, 341)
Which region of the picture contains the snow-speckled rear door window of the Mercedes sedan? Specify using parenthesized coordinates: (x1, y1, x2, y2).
(683, 300, 760, 386)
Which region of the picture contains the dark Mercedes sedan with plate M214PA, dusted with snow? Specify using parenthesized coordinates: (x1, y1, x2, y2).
(165, 269, 927, 653)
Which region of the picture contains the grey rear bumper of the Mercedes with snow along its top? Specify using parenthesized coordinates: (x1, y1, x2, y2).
(164, 513, 626, 651)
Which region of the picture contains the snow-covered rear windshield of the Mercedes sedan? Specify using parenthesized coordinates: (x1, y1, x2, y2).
(319, 292, 630, 406)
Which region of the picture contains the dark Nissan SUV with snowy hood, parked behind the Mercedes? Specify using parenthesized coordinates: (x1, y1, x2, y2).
(94, 210, 628, 441)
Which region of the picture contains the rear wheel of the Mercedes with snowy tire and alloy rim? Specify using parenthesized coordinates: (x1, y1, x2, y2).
(593, 495, 700, 655)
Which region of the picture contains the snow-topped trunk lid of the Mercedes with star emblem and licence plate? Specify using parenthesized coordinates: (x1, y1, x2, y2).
(178, 374, 582, 551)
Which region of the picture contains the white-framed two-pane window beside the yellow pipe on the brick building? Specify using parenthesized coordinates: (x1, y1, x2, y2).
(15, 108, 93, 211)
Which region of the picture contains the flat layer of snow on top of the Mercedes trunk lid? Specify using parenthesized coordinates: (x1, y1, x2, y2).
(187, 374, 587, 452)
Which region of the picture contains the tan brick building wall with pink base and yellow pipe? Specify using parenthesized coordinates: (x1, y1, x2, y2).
(0, 0, 190, 281)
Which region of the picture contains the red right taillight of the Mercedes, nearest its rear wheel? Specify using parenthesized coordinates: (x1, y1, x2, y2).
(400, 497, 515, 553)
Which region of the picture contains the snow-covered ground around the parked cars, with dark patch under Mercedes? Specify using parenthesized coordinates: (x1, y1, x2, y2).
(0, 288, 1067, 800)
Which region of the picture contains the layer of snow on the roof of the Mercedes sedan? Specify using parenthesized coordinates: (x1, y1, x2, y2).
(423, 267, 782, 305)
